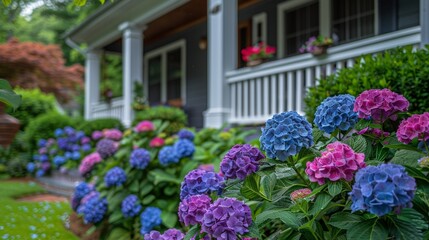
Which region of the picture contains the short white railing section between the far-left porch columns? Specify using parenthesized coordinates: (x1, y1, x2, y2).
(91, 98, 124, 120)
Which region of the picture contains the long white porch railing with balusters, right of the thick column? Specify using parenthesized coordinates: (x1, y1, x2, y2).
(226, 27, 420, 124)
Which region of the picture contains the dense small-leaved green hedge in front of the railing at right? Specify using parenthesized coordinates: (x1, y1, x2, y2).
(305, 47, 429, 122)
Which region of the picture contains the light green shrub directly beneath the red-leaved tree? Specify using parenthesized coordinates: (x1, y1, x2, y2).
(8, 88, 56, 129)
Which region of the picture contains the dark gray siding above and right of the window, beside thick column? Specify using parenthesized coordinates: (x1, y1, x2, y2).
(144, 22, 207, 128)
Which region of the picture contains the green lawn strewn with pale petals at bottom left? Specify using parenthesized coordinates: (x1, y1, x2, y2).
(0, 181, 78, 240)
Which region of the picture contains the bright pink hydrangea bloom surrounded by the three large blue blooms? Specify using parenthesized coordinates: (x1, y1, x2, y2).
(305, 142, 366, 185)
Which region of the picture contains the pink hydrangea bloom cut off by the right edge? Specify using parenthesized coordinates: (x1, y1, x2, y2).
(396, 112, 429, 144)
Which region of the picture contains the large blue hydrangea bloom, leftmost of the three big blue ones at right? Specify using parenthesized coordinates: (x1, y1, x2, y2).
(260, 111, 313, 161)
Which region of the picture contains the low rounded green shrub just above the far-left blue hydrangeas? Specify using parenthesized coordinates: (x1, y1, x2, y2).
(24, 113, 81, 150)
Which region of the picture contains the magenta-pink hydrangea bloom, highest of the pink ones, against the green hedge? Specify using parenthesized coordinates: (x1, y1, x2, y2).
(353, 89, 410, 123)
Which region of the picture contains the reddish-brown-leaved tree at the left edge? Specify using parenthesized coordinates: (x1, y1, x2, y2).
(0, 39, 84, 102)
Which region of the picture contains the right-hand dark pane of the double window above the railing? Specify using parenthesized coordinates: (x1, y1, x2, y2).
(331, 0, 375, 43)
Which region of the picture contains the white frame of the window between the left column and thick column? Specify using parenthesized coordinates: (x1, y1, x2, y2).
(143, 39, 186, 105)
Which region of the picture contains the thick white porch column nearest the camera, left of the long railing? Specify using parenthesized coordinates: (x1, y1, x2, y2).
(204, 0, 237, 127)
